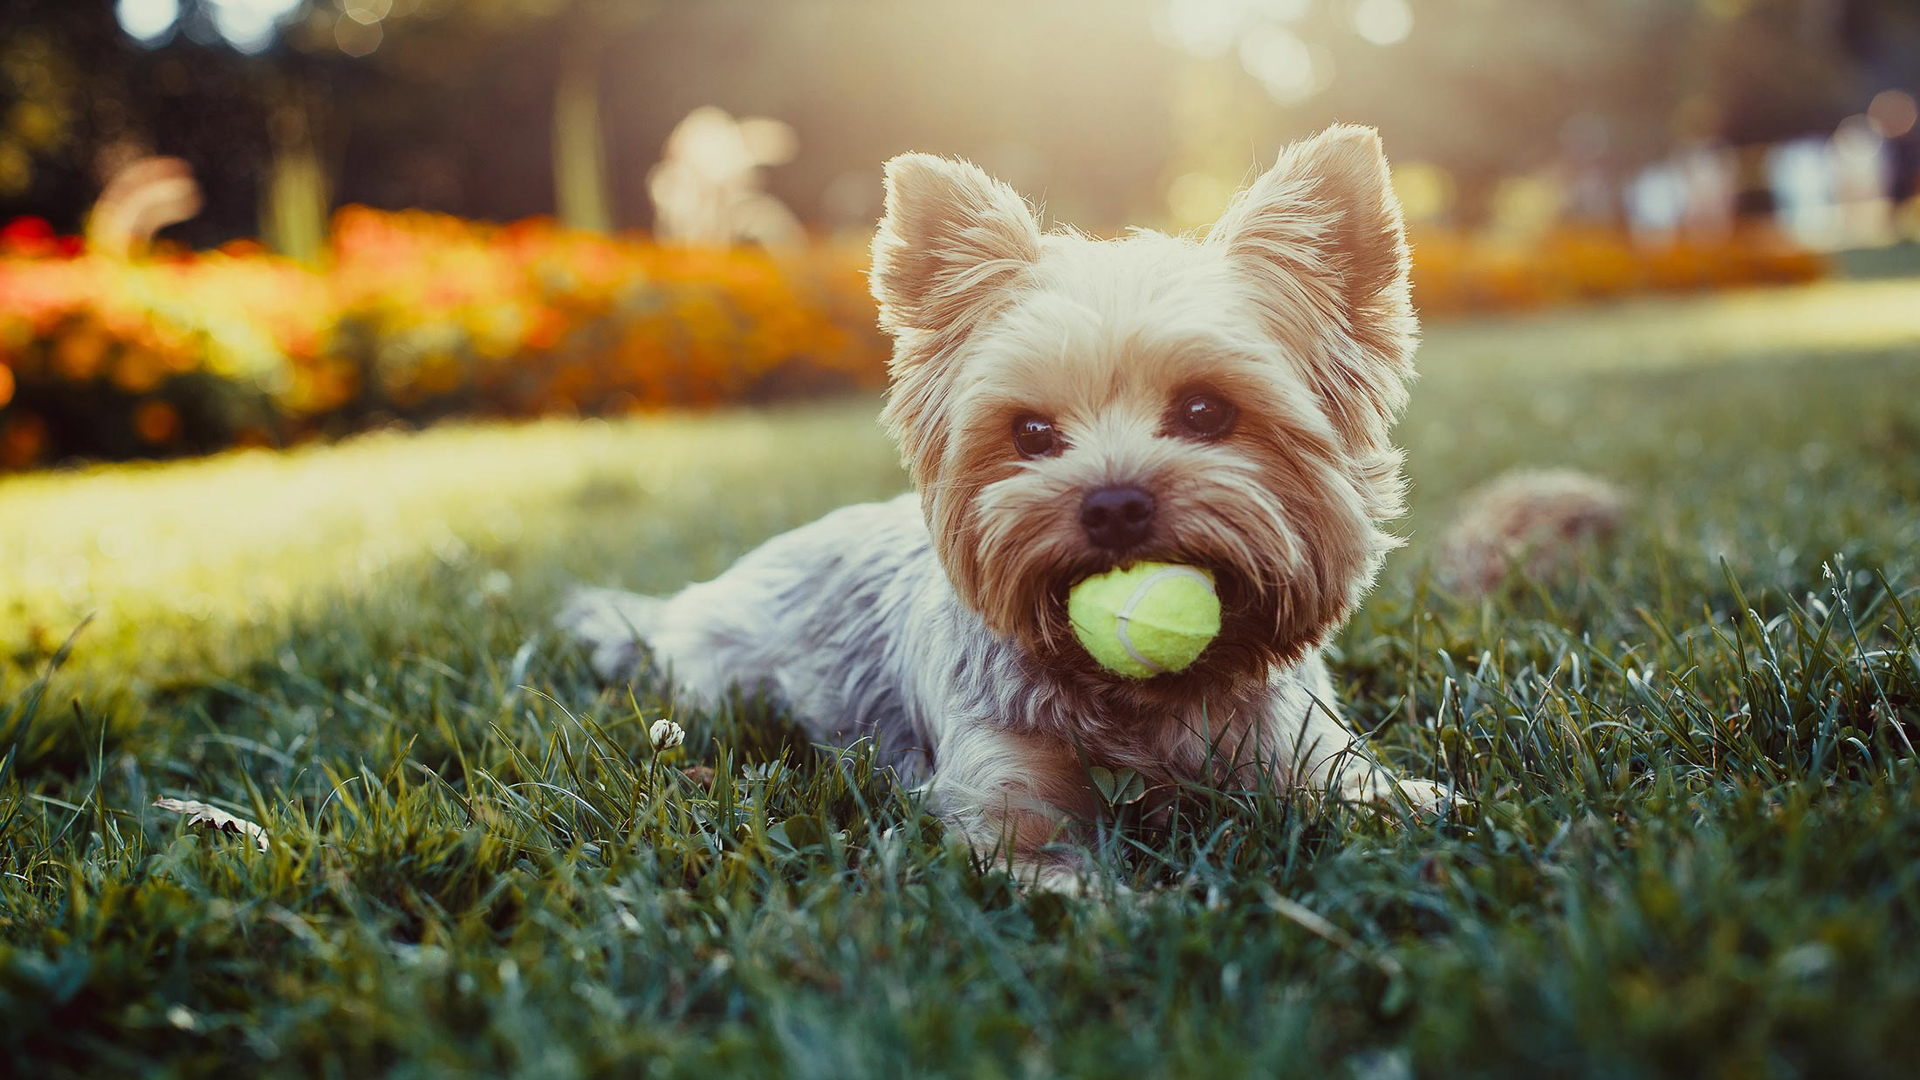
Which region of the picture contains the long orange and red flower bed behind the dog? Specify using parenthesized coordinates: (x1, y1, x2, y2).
(0, 208, 1824, 469)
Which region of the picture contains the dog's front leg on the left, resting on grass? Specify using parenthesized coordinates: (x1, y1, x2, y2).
(931, 721, 1098, 894)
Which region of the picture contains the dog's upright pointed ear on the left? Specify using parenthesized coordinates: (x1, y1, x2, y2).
(872, 154, 1041, 332)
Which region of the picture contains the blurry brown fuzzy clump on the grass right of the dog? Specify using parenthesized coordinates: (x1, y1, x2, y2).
(1434, 469, 1632, 598)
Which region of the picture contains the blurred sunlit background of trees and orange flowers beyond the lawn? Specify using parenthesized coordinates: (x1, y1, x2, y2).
(0, 0, 1920, 469)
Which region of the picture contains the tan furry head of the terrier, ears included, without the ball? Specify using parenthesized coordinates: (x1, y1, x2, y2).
(872, 127, 1415, 678)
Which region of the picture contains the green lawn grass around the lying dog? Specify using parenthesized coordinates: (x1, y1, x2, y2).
(0, 279, 1920, 1078)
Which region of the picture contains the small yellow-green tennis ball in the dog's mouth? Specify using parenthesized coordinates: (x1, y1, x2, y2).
(1068, 563, 1219, 678)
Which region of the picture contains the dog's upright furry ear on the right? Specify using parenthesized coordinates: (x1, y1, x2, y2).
(1208, 125, 1419, 450)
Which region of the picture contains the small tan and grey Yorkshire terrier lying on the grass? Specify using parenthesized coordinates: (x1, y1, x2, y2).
(559, 125, 1448, 890)
